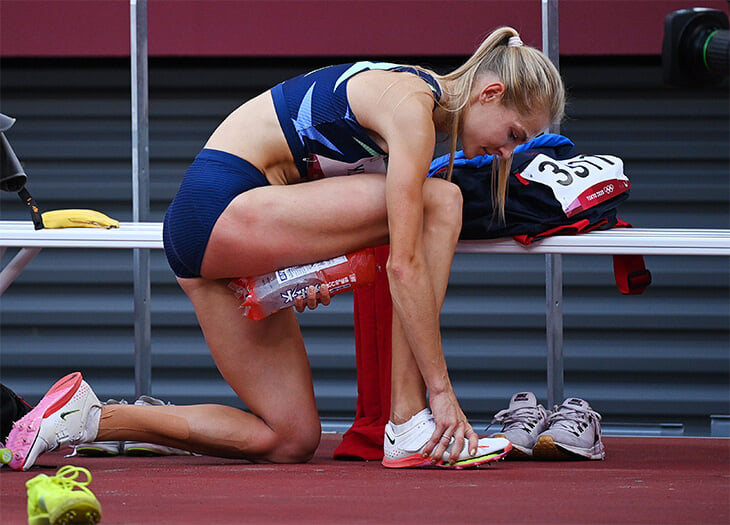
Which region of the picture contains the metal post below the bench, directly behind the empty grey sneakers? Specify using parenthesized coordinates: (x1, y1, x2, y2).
(545, 254, 563, 409)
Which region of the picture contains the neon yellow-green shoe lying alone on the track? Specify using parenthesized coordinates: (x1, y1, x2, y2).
(25, 465, 101, 525)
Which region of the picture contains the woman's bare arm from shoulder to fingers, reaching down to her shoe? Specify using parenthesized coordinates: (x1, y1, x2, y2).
(358, 73, 477, 459)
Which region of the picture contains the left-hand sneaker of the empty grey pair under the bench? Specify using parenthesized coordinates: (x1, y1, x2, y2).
(487, 392, 549, 459)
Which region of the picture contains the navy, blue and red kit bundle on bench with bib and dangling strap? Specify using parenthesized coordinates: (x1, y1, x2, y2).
(429, 134, 651, 295)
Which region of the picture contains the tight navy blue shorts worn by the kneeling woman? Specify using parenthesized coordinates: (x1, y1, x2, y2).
(162, 149, 269, 277)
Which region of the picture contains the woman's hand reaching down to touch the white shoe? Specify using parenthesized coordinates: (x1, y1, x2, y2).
(423, 390, 479, 465)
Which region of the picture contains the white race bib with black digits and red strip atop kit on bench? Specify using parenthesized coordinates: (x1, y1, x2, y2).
(520, 153, 631, 217)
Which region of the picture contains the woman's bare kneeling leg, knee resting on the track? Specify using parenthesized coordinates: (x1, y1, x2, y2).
(97, 279, 321, 462)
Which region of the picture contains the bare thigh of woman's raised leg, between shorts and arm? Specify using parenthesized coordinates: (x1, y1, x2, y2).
(201, 175, 388, 279)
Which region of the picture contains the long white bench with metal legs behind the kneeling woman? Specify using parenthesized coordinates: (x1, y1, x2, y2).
(0, 221, 730, 406)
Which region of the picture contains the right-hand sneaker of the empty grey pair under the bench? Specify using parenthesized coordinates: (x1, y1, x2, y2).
(532, 397, 605, 460)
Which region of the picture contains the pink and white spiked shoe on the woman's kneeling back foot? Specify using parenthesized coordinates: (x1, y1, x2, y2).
(6, 372, 101, 470)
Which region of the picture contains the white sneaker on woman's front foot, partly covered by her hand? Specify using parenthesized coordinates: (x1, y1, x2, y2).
(383, 408, 512, 469)
